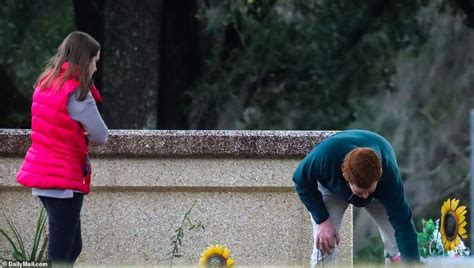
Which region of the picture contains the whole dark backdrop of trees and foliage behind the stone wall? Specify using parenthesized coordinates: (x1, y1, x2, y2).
(0, 0, 474, 259)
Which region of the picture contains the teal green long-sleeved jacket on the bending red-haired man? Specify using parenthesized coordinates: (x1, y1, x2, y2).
(293, 130, 419, 262)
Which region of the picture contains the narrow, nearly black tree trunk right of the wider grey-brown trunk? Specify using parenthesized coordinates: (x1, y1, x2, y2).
(158, 0, 201, 129)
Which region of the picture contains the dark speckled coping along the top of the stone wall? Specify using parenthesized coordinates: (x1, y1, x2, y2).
(0, 129, 335, 157)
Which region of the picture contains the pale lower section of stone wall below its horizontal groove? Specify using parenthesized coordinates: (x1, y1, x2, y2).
(0, 189, 352, 266)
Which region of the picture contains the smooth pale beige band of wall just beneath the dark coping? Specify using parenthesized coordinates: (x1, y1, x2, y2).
(0, 157, 298, 187)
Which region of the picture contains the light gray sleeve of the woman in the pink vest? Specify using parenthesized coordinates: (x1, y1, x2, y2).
(67, 91, 108, 145)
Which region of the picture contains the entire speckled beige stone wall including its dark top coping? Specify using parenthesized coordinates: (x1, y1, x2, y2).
(0, 130, 352, 267)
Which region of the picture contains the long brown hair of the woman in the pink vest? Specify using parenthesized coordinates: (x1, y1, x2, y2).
(35, 31, 100, 101)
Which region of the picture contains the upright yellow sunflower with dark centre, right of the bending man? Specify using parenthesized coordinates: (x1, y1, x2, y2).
(440, 198, 467, 251)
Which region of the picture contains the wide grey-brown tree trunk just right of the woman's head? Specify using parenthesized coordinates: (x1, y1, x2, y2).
(101, 0, 162, 129)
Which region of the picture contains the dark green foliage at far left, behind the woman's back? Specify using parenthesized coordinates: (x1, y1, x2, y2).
(0, 0, 73, 128)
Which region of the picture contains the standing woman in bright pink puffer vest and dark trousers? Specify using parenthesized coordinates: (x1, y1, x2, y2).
(17, 32, 107, 265)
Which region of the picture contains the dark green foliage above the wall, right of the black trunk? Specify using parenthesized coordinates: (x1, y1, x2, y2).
(190, 0, 425, 129)
